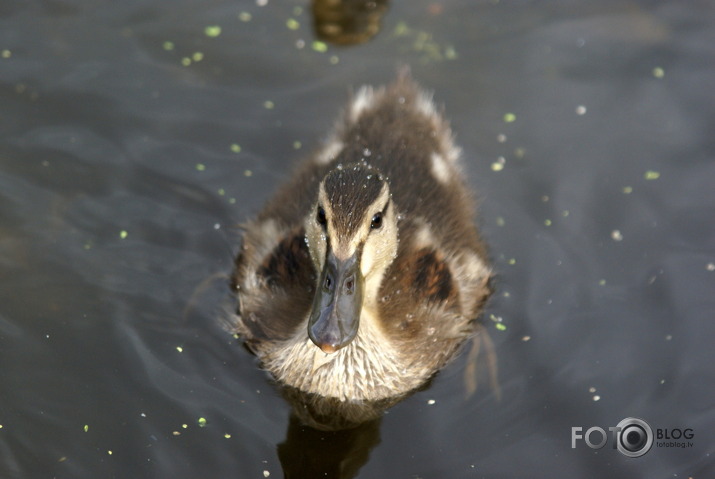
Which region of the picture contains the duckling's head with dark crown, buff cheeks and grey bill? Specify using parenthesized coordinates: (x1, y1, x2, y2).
(305, 163, 398, 353)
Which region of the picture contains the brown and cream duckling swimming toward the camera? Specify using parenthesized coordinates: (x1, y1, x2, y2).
(229, 70, 492, 430)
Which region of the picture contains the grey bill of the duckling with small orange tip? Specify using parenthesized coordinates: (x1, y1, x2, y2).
(308, 251, 364, 353)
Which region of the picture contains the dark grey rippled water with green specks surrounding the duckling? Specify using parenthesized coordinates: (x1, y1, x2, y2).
(0, 0, 715, 479)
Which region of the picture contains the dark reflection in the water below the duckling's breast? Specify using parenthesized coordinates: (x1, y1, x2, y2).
(278, 416, 380, 479)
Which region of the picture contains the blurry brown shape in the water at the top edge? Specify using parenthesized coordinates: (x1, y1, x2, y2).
(313, 0, 388, 45)
